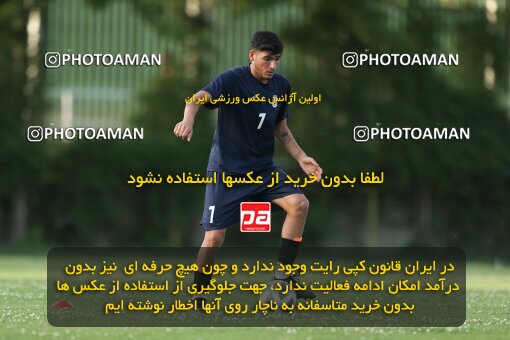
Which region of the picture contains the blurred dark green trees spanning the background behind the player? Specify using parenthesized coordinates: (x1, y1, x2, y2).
(0, 0, 510, 257)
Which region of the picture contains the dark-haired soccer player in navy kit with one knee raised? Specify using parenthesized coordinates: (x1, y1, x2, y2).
(174, 31, 322, 302)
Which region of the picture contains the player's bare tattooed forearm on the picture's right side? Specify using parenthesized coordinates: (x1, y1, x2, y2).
(275, 119, 322, 181)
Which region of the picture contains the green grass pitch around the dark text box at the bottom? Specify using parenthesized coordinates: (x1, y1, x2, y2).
(0, 255, 510, 340)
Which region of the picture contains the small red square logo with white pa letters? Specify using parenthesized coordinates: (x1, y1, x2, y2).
(241, 202, 271, 233)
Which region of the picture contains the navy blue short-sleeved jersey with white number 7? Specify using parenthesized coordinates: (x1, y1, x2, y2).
(202, 66, 290, 174)
